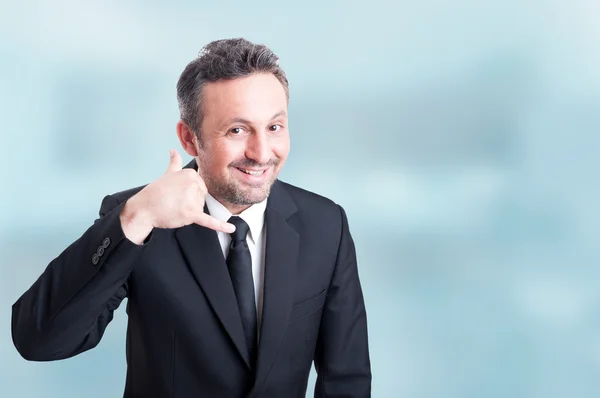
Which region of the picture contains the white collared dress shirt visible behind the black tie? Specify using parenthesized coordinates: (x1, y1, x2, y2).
(205, 193, 267, 335)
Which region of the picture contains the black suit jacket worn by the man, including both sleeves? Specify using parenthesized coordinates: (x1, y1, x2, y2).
(12, 161, 371, 398)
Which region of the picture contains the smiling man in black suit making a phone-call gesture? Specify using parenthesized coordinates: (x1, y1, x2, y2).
(12, 39, 371, 398)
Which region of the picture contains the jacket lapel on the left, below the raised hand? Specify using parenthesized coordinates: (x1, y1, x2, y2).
(175, 160, 250, 367)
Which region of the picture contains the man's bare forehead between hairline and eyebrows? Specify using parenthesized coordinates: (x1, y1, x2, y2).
(202, 73, 287, 124)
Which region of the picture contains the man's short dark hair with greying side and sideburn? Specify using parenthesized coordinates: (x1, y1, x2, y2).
(177, 38, 289, 140)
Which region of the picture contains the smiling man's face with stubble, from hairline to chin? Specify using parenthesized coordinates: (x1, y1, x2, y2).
(197, 74, 290, 211)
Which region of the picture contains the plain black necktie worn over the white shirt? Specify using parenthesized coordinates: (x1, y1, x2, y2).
(227, 216, 257, 364)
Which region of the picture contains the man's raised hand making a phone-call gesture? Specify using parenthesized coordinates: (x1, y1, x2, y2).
(121, 149, 235, 244)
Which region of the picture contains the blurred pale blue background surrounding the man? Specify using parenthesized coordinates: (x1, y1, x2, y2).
(0, 0, 600, 398)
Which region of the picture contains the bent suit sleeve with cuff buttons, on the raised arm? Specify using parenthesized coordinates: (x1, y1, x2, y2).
(12, 196, 145, 361)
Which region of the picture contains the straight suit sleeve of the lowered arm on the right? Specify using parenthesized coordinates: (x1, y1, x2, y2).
(314, 207, 371, 398)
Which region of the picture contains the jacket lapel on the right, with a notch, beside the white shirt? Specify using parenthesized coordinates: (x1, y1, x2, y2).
(255, 181, 299, 394)
